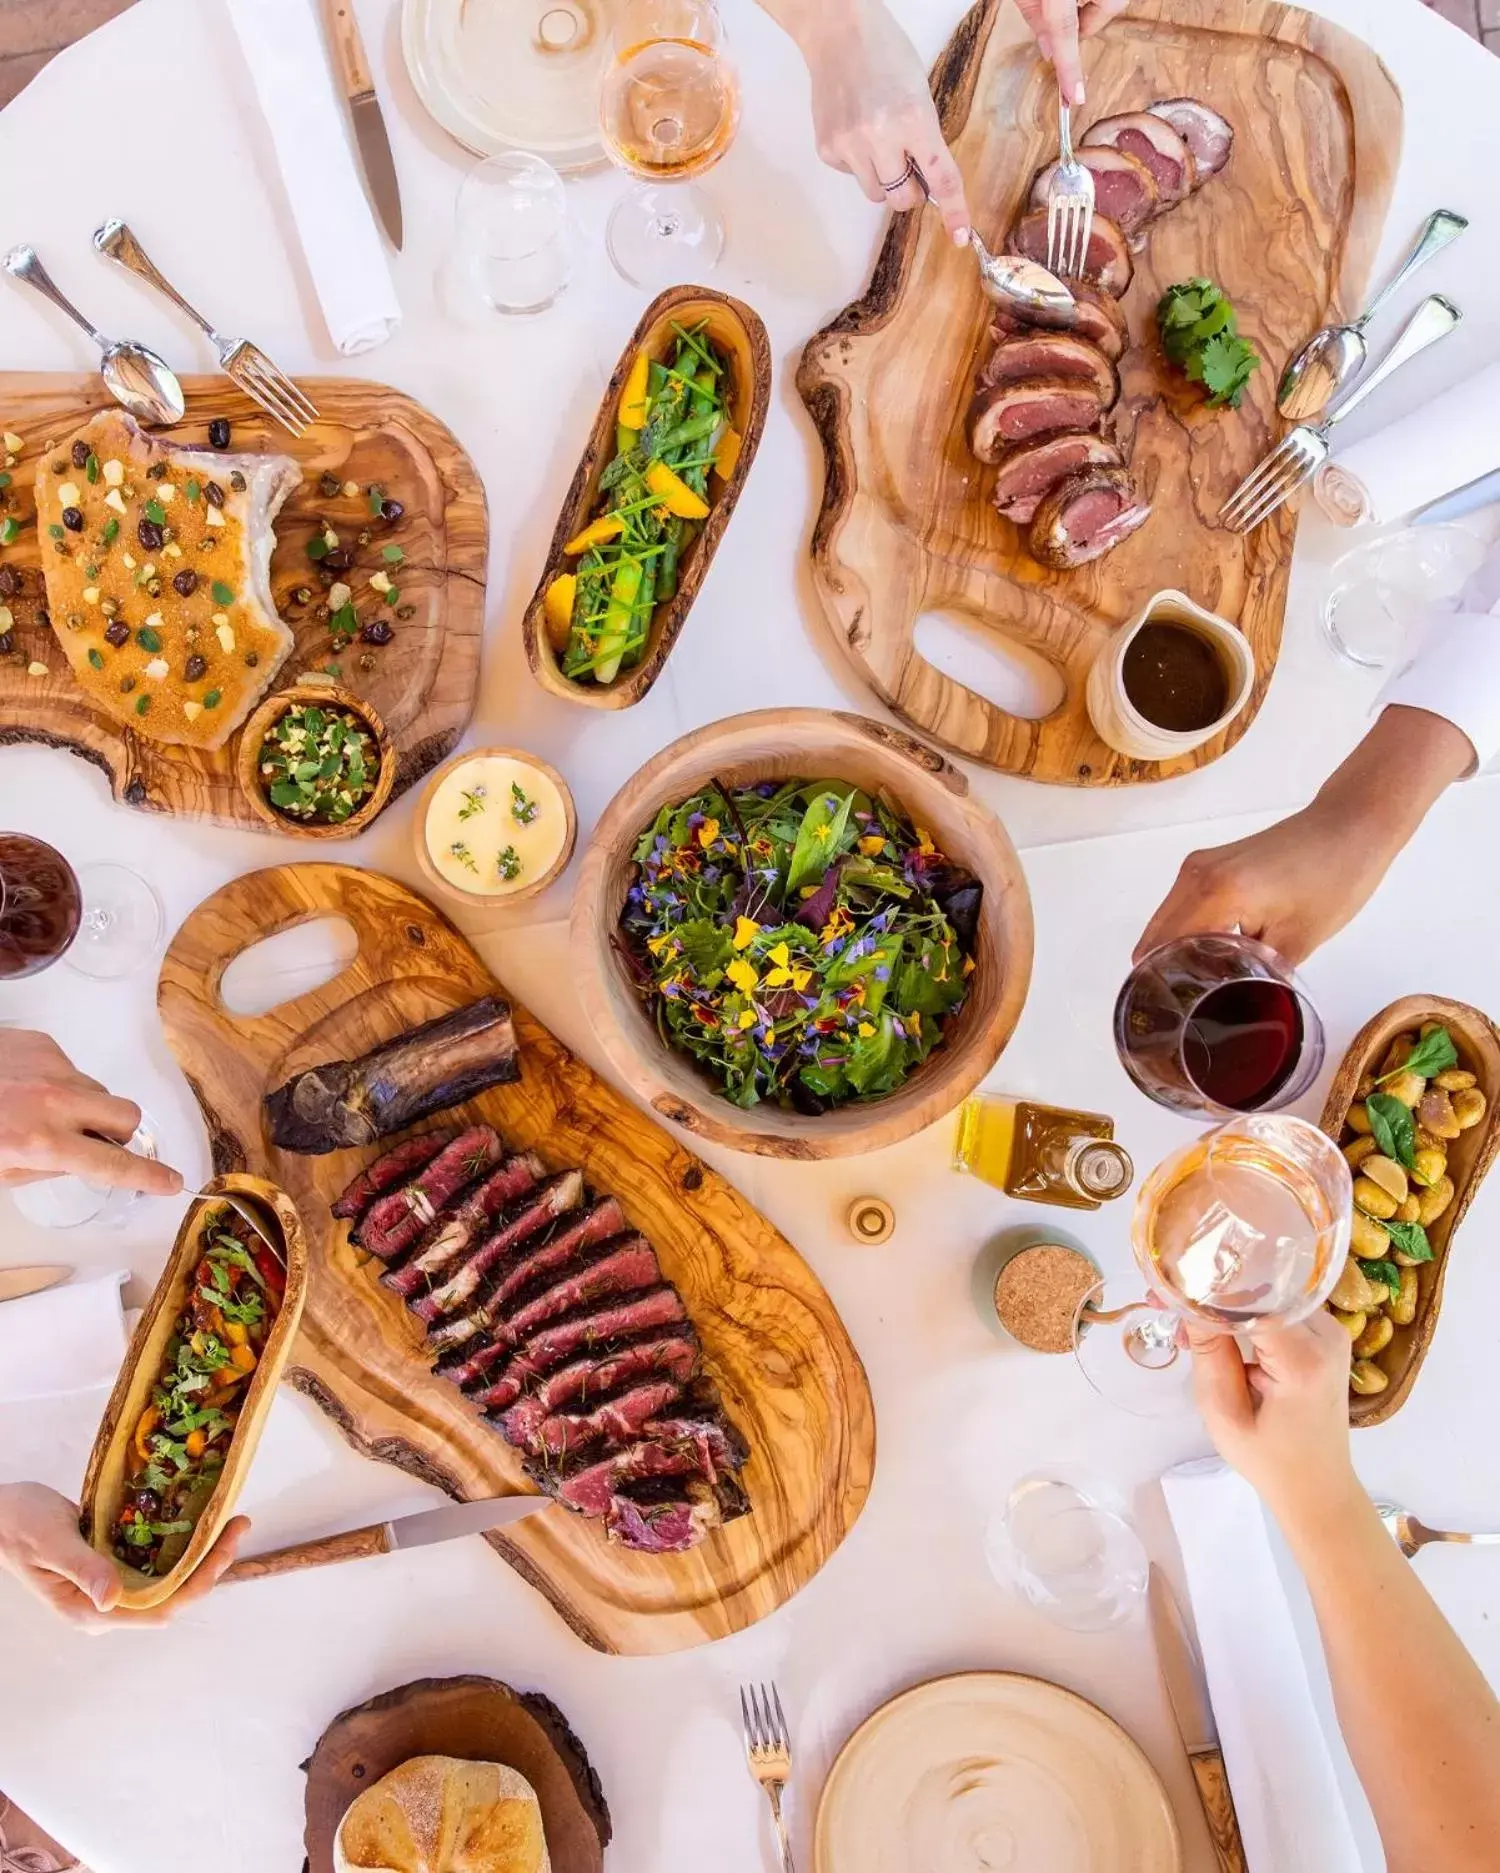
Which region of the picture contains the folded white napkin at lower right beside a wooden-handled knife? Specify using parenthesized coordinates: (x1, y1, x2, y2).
(1161, 1461, 1363, 1873)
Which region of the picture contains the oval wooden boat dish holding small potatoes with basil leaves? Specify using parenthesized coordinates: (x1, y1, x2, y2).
(1320, 995, 1500, 1425)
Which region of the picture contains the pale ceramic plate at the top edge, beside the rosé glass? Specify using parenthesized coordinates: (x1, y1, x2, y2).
(401, 0, 610, 174)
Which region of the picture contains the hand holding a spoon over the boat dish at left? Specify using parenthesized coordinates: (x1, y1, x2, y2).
(0, 1028, 182, 1197)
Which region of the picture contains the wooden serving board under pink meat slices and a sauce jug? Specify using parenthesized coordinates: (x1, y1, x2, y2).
(798, 0, 1401, 787)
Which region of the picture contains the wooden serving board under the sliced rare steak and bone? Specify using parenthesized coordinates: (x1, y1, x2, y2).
(157, 865, 875, 1652)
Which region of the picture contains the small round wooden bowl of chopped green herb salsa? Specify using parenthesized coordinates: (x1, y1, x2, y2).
(236, 674, 395, 839)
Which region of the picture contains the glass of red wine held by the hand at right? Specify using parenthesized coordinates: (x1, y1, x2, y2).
(1114, 935, 1324, 1114)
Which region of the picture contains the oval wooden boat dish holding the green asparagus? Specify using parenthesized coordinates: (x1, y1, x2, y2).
(521, 287, 772, 708)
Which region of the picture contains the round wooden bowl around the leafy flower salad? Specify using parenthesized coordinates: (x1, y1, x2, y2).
(571, 708, 1032, 1158)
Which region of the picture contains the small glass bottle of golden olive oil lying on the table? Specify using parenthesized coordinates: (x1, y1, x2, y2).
(953, 1094, 1135, 1210)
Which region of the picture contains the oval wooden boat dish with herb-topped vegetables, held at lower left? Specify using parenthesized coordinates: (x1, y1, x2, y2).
(82, 1172, 307, 1611)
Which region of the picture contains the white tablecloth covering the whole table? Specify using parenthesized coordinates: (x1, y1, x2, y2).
(0, 0, 1500, 1873)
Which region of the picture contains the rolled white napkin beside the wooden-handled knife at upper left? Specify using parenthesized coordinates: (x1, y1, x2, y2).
(228, 0, 401, 358)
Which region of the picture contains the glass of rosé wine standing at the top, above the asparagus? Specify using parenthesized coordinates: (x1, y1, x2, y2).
(599, 0, 740, 290)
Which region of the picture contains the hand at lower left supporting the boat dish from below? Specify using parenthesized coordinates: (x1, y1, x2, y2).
(0, 1483, 249, 1631)
